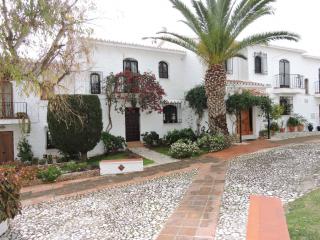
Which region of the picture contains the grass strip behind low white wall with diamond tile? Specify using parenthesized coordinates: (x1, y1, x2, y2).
(87, 151, 154, 167)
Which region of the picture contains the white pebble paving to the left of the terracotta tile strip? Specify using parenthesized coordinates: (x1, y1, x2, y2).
(0, 170, 197, 240)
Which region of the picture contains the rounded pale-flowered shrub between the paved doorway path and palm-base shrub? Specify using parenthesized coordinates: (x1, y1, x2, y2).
(169, 139, 200, 159)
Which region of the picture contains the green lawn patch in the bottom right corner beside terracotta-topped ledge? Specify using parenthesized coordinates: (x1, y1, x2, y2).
(287, 189, 320, 240)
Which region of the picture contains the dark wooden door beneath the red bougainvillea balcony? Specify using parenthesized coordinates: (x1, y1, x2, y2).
(125, 108, 140, 142)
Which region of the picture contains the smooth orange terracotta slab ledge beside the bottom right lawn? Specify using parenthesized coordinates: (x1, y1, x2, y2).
(247, 196, 290, 240)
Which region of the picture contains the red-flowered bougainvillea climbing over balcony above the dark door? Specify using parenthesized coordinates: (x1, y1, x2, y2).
(104, 71, 165, 132)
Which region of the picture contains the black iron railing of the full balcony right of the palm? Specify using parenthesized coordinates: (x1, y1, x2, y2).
(275, 74, 305, 89)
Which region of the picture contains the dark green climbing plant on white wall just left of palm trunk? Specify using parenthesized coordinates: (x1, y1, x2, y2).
(186, 85, 208, 134)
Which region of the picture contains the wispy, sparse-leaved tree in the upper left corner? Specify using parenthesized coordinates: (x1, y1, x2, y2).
(0, 0, 93, 112)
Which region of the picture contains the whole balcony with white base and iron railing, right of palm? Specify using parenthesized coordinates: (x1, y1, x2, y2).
(273, 74, 305, 94)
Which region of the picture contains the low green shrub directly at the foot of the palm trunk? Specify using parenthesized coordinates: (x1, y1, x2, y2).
(197, 133, 231, 152)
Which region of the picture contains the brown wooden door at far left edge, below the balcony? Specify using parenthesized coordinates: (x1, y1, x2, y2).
(0, 132, 14, 164)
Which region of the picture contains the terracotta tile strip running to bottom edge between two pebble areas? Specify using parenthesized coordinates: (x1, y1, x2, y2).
(157, 161, 227, 240)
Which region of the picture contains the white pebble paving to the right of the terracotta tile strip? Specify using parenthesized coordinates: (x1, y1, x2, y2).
(216, 143, 320, 240)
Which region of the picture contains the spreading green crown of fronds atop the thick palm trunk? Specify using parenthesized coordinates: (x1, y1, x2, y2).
(145, 0, 299, 64)
